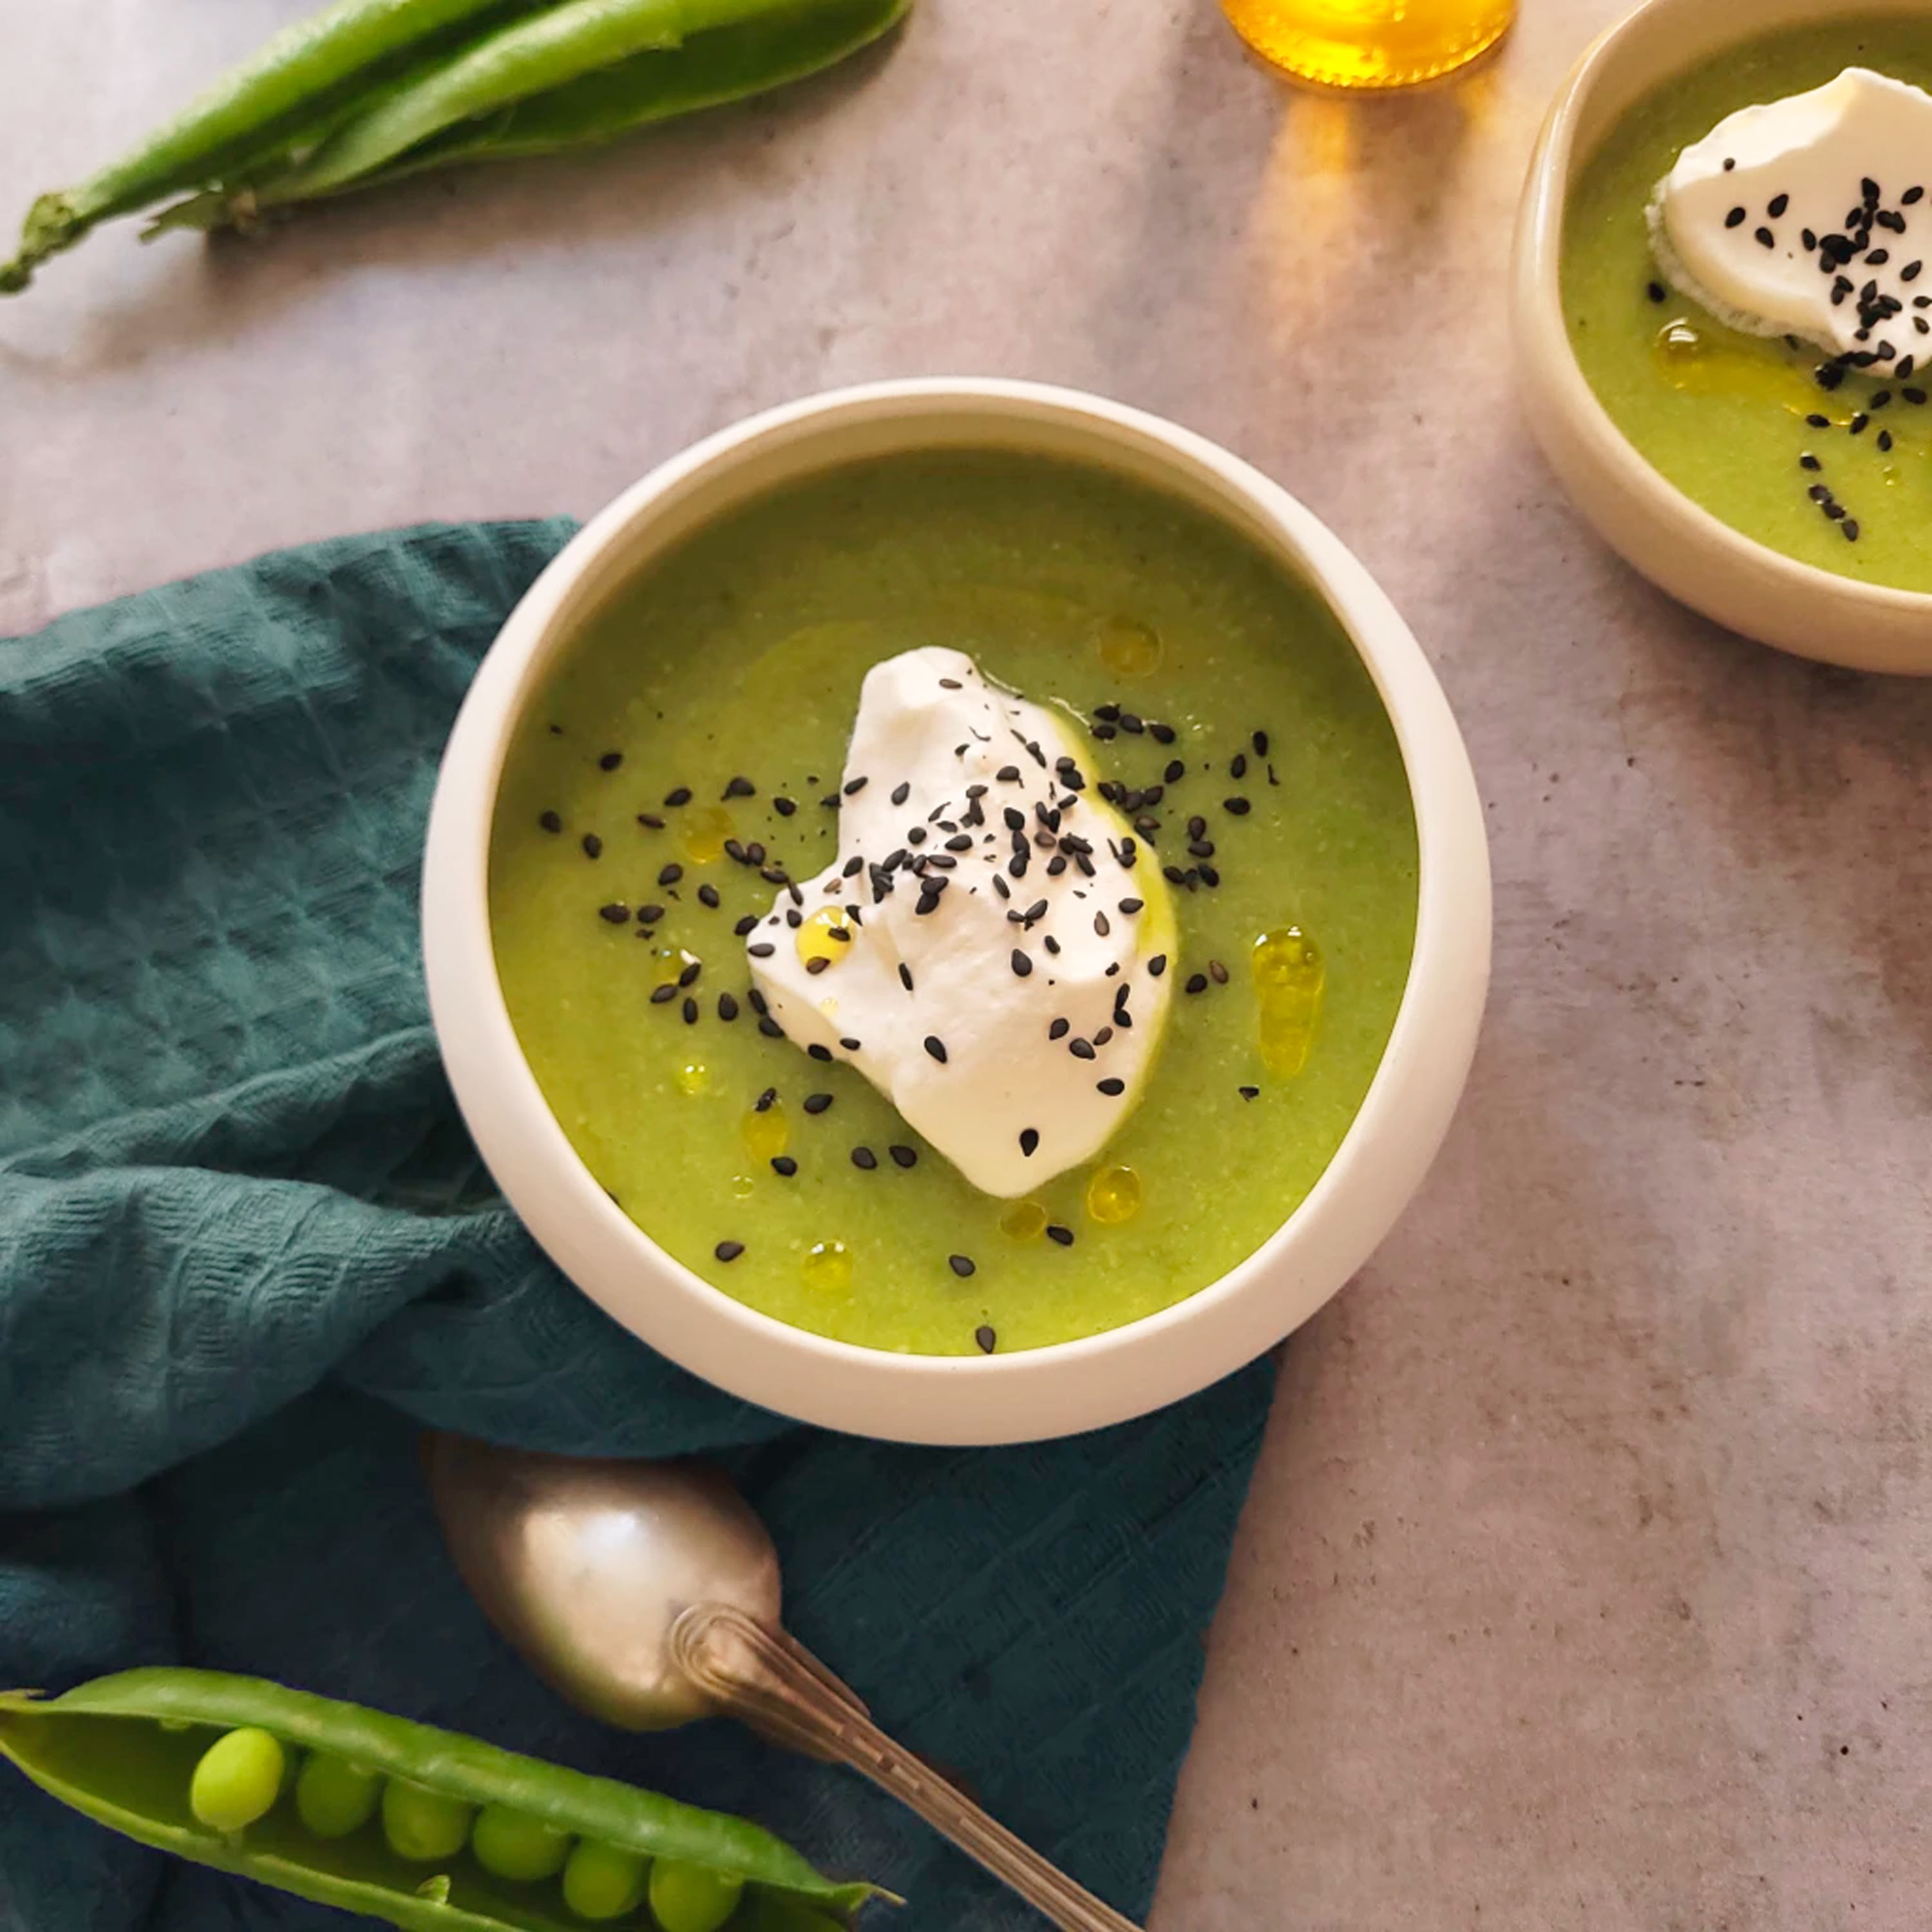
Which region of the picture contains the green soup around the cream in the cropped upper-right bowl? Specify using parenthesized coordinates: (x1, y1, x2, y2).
(1563, 14, 1932, 591)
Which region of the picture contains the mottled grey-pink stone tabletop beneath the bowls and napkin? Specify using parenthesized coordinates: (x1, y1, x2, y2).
(0, 0, 1932, 1932)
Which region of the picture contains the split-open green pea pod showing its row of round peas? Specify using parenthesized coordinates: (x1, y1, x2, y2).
(0, 1669, 887, 1932)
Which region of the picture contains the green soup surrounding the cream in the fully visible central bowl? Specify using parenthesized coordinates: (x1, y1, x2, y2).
(489, 450, 1418, 1354)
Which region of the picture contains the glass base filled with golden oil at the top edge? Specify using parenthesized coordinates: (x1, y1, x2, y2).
(1221, 0, 1517, 87)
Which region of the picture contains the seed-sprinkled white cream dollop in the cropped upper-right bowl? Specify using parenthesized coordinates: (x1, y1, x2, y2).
(1650, 68, 1932, 375)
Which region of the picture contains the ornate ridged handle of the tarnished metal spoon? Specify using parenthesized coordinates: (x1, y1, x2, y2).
(670, 1604, 1138, 1932)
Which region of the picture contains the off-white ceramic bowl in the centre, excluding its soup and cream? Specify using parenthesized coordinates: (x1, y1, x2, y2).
(423, 381, 1490, 1443)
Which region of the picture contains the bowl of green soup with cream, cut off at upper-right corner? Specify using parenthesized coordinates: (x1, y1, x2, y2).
(1513, 0, 1932, 672)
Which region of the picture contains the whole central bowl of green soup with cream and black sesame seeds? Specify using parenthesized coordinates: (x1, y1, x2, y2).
(423, 381, 1490, 1443)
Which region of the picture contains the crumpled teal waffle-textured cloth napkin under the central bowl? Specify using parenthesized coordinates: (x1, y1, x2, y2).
(0, 522, 1269, 1932)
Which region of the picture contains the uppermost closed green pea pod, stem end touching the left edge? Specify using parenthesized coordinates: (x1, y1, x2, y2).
(0, 0, 543, 294)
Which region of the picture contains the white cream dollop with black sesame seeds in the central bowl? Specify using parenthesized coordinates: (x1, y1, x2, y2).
(746, 647, 1175, 1198)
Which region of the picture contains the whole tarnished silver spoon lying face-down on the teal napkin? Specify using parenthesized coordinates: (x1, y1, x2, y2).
(423, 1434, 1136, 1932)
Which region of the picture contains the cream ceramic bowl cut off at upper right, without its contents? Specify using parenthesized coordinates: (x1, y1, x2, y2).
(1513, 0, 1932, 674)
